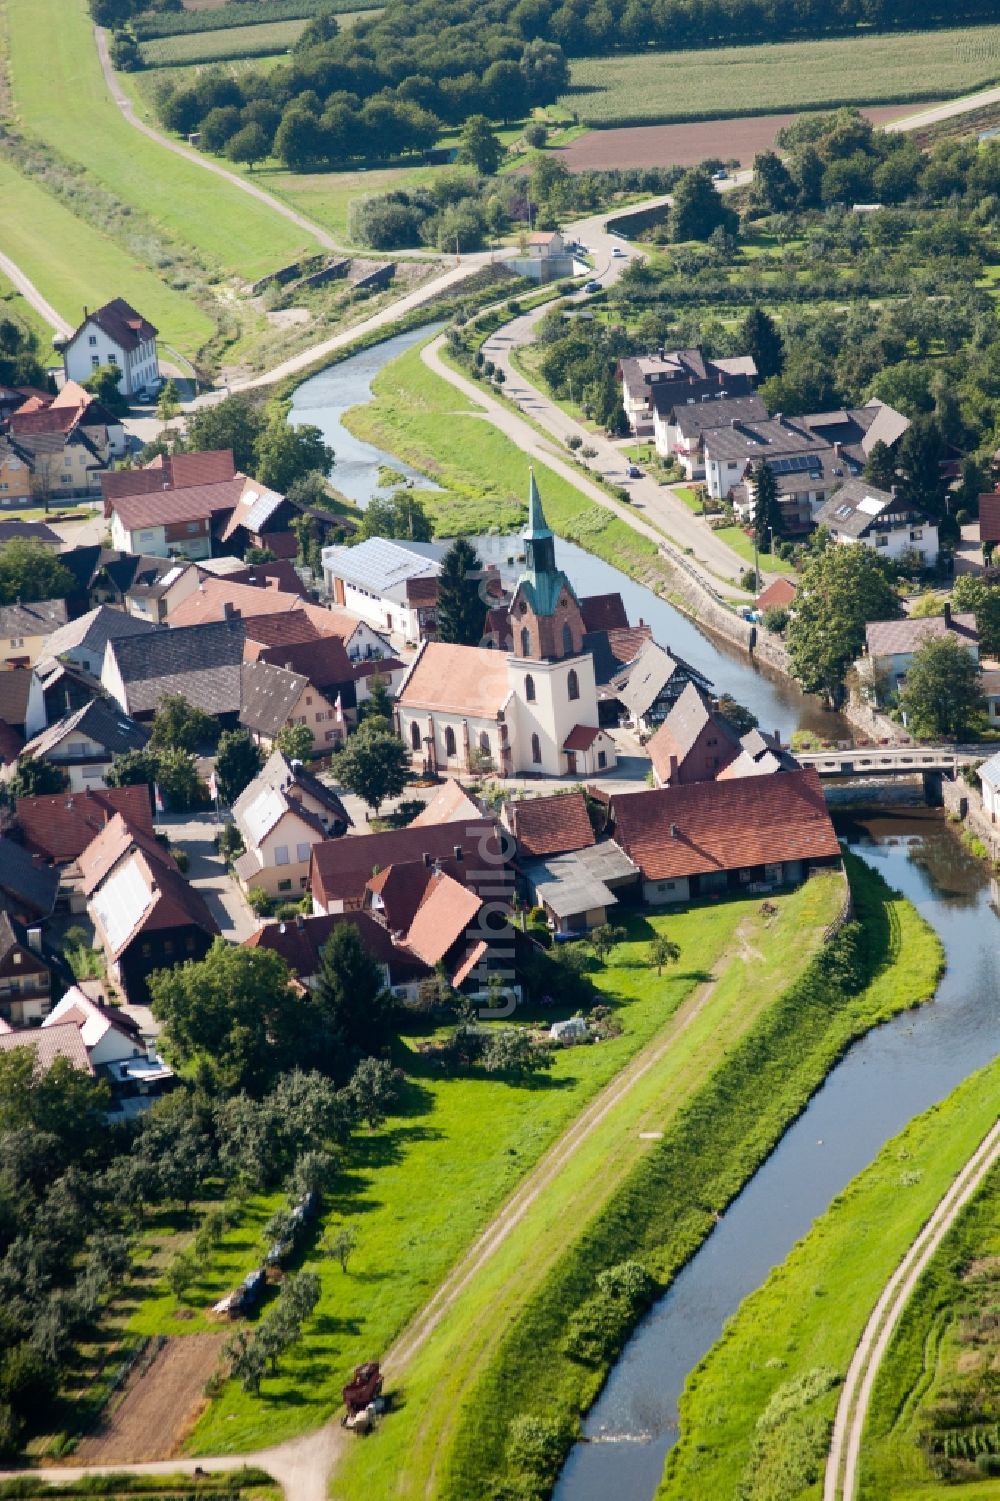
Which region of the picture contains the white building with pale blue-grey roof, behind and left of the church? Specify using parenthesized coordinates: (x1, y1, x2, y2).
(323, 537, 447, 641)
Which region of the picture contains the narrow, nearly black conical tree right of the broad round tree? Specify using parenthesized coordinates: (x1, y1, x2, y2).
(309, 923, 395, 1080)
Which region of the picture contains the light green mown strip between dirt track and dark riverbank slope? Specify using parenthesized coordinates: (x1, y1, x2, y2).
(333, 875, 842, 1498)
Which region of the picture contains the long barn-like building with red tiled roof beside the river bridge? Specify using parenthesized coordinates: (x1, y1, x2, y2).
(611, 769, 841, 905)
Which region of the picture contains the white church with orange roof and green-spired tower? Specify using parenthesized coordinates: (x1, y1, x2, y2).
(396, 473, 616, 776)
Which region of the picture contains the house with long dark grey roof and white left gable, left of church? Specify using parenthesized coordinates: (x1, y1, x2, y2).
(101, 620, 243, 722)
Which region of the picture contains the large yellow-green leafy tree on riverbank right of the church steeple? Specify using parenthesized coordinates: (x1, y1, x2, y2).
(787, 545, 902, 705)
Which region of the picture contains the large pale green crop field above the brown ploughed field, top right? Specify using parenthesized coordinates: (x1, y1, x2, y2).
(560, 26, 1000, 126)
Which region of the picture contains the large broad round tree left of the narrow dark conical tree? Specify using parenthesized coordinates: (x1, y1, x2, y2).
(149, 938, 303, 1096)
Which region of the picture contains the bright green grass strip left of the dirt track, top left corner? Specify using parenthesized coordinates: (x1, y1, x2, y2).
(5, 0, 307, 282)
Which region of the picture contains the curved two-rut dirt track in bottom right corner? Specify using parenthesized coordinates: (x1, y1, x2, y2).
(823, 1121, 1000, 1501)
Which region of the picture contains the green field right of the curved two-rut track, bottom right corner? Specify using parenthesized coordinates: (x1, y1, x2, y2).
(859, 1158, 1000, 1501)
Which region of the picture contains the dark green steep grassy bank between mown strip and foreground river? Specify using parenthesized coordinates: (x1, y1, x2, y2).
(423, 862, 941, 1501)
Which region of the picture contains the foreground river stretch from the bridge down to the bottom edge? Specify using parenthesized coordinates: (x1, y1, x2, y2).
(554, 809, 1000, 1501)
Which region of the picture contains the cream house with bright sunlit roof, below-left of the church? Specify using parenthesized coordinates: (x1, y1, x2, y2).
(233, 752, 350, 901)
